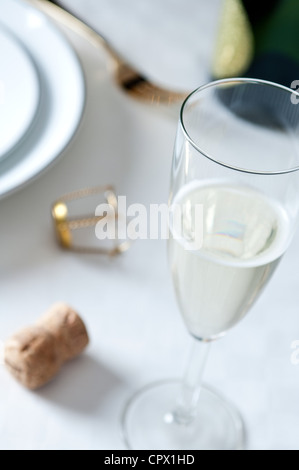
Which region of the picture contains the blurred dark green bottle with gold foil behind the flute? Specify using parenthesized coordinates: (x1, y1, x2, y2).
(213, 0, 299, 87)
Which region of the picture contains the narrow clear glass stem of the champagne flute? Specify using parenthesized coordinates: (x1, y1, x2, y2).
(173, 339, 211, 425)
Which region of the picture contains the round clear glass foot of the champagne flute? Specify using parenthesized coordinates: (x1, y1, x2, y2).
(122, 380, 245, 450)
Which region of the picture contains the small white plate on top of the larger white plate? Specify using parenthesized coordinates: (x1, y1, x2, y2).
(0, 28, 40, 159)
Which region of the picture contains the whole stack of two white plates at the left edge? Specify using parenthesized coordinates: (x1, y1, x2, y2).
(0, 0, 85, 197)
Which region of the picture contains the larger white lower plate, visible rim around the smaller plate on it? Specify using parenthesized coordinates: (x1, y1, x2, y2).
(0, 0, 85, 197)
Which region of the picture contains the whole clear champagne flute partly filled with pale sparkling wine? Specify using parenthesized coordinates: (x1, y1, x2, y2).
(123, 79, 299, 450)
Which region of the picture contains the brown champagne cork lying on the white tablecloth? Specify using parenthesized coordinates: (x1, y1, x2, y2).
(4, 303, 89, 390)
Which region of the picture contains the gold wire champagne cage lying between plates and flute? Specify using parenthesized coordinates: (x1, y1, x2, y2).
(52, 186, 130, 256)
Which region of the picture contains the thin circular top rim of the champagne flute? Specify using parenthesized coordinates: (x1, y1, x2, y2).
(180, 77, 299, 176)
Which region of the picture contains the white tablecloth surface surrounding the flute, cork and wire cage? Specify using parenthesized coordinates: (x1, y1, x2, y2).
(0, 0, 299, 450)
